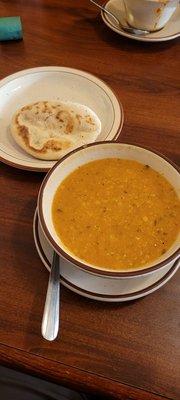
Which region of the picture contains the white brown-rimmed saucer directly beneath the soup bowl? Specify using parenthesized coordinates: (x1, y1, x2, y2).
(33, 211, 180, 302)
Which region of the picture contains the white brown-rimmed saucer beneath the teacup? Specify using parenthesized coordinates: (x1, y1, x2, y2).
(101, 0, 180, 42)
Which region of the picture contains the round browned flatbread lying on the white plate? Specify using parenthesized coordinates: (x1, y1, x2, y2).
(11, 101, 101, 160)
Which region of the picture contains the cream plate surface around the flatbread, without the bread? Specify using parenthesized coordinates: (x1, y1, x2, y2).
(0, 67, 124, 172)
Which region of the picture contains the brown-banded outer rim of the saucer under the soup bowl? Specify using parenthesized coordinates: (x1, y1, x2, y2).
(33, 208, 180, 302)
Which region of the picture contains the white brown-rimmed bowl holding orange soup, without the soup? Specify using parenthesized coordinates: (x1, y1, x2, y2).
(38, 142, 180, 293)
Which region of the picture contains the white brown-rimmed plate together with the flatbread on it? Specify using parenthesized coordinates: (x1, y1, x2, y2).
(0, 67, 124, 172)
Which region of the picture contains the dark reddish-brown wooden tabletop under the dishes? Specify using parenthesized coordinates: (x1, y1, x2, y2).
(0, 0, 180, 400)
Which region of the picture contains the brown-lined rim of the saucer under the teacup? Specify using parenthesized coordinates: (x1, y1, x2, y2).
(101, 0, 180, 43)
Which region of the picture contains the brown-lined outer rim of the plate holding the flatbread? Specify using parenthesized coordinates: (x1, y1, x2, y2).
(0, 66, 124, 172)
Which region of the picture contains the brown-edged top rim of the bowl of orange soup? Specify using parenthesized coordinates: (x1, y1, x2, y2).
(37, 141, 180, 278)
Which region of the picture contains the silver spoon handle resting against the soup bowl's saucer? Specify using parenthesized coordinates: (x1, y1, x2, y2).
(41, 251, 60, 341)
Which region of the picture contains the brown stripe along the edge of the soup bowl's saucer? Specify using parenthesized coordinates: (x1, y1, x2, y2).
(34, 209, 180, 301)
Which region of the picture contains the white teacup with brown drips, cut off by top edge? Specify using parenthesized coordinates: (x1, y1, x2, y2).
(124, 0, 179, 32)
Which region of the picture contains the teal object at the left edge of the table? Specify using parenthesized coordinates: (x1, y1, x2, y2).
(0, 17, 23, 41)
